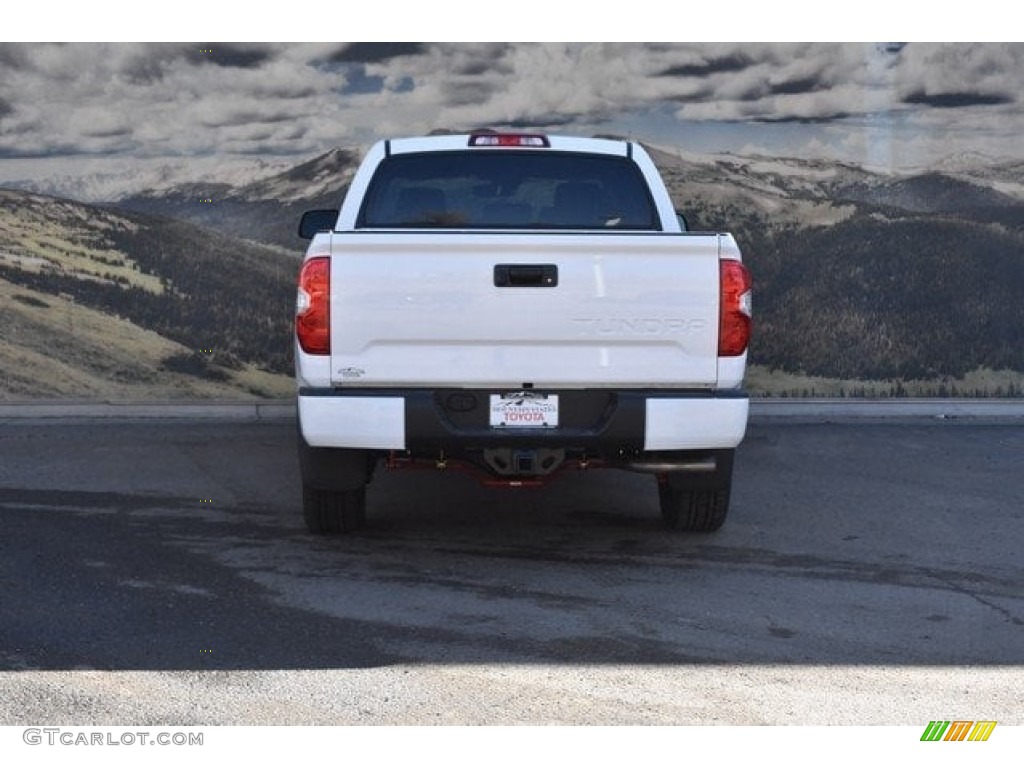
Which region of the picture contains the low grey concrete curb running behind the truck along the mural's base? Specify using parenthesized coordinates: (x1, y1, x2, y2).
(0, 398, 1024, 423)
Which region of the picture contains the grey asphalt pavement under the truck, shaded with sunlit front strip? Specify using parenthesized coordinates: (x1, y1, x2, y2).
(0, 403, 1024, 727)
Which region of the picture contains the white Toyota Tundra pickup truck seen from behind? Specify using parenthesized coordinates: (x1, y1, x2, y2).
(295, 131, 751, 534)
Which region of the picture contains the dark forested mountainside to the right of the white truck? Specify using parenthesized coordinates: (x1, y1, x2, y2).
(655, 148, 1024, 393)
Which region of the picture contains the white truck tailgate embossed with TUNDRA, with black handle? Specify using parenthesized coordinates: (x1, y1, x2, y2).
(331, 231, 719, 388)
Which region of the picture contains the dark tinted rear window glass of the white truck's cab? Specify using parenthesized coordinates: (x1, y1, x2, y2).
(357, 150, 659, 229)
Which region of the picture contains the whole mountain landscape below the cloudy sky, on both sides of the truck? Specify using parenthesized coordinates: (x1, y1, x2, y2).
(0, 140, 1024, 399)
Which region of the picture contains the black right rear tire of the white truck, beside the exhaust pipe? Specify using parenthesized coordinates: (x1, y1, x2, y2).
(657, 451, 733, 532)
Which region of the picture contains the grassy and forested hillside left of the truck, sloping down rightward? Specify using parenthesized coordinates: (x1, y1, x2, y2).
(0, 189, 298, 399)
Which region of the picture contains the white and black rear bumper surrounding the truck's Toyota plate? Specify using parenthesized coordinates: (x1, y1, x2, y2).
(298, 388, 750, 459)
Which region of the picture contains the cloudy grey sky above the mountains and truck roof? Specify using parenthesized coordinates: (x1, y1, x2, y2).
(0, 42, 1024, 196)
